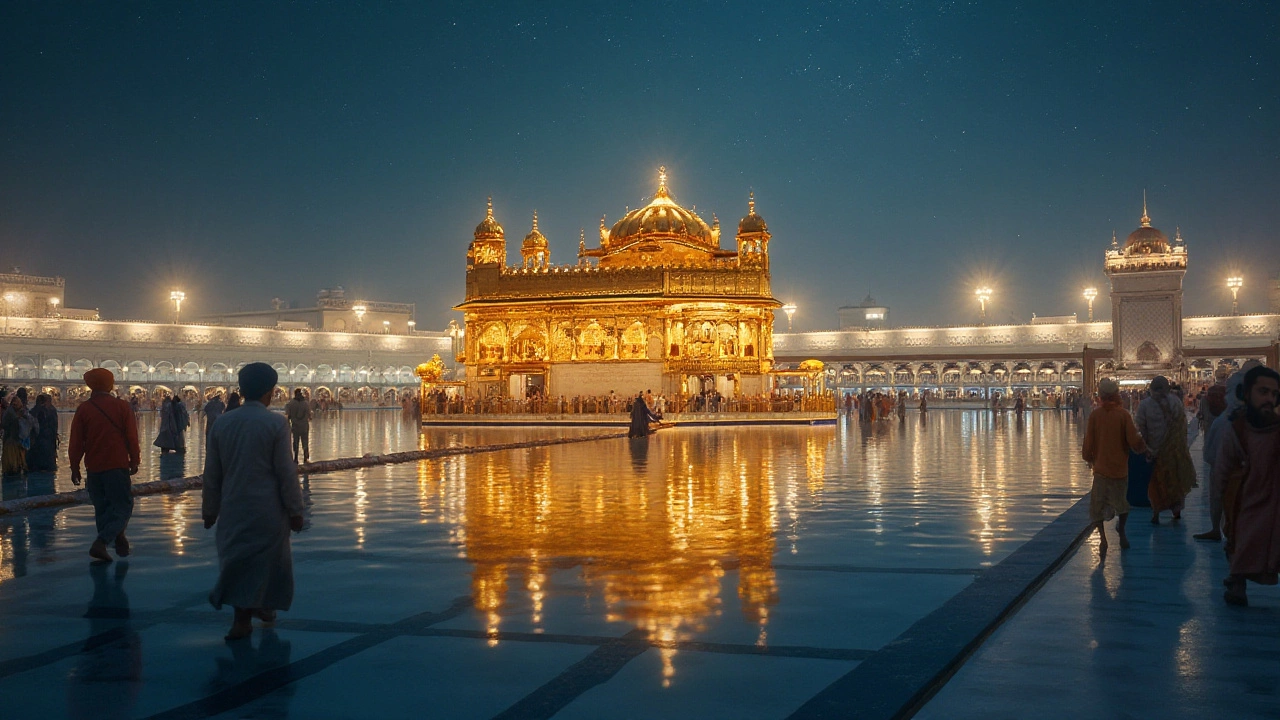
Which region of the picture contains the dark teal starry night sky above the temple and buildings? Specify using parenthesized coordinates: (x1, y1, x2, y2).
(0, 1, 1280, 331)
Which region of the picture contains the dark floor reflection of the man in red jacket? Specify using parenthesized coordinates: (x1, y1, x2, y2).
(67, 563, 142, 720)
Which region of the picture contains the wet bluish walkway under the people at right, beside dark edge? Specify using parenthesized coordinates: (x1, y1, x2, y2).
(916, 445, 1280, 720)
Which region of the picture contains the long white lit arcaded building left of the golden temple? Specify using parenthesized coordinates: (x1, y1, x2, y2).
(0, 270, 456, 405)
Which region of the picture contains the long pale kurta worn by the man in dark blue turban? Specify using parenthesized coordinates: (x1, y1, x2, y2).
(202, 402, 303, 610)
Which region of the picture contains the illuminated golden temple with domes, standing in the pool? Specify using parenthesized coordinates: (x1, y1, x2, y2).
(454, 168, 781, 398)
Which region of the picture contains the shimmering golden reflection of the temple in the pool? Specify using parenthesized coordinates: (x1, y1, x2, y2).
(419, 430, 835, 683)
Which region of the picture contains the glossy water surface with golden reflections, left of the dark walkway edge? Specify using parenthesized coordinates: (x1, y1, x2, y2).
(0, 410, 1249, 719)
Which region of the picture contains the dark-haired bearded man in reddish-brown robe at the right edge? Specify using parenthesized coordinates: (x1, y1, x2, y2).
(1213, 366, 1280, 606)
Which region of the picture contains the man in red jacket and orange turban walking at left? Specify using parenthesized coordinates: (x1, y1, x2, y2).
(67, 368, 141, 562)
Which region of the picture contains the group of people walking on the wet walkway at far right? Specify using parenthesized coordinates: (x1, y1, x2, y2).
(1082, 361, 1280, 606)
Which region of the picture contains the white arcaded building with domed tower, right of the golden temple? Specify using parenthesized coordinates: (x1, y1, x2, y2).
(773, 204, 1280, 397)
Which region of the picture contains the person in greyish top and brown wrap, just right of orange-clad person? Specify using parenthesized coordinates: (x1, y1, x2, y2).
(1134, 375, 1196, 525)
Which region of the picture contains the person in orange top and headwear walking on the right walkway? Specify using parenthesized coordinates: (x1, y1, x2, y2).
(1080, 378, 1147, 553)
